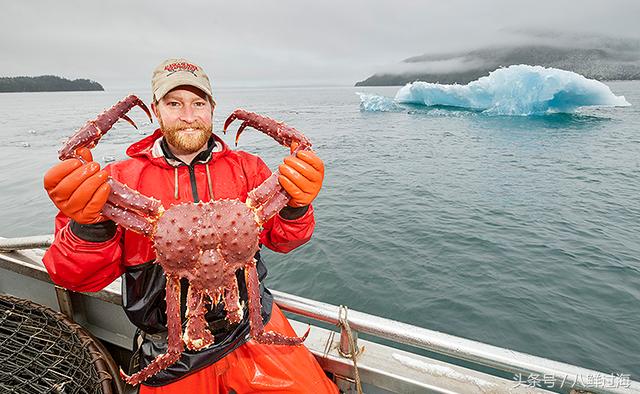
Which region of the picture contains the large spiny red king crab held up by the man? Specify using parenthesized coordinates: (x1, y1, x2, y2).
(59, 95, 311, 385)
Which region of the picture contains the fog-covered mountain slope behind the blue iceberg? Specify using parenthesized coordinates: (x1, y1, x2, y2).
(356, 44, 640, 86)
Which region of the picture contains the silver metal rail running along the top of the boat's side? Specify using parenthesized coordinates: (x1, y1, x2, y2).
(0, 235, 640, 394)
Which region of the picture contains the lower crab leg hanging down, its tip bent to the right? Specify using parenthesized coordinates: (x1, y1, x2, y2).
(245, 260, 309, 345)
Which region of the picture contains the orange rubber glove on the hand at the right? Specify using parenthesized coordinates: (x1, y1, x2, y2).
(278, 142, 324, 208)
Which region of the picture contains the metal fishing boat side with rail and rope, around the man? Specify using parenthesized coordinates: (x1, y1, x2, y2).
(0, 235, 640, 394)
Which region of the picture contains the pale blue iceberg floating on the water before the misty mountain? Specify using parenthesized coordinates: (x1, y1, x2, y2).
(360, 64, 631, 116)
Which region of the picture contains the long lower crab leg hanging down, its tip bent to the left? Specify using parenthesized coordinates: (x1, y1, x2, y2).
(120, 275, 184, 386)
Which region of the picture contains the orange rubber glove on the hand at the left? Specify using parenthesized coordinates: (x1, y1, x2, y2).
(44, 148, 111, 224)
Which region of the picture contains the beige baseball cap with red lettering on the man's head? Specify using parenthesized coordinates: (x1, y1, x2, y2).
(151, 59, 216, 105)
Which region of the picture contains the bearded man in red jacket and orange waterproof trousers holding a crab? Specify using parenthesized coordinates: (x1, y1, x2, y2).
(43, 59, 337, 394)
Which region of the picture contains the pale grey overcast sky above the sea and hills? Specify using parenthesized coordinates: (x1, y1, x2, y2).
(0, 0, 640, 90)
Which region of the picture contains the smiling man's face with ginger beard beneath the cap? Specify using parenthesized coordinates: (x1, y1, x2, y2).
(153, 86, 213, 155)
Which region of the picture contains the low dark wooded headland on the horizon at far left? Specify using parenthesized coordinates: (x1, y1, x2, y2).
(0, 75, 104, 93)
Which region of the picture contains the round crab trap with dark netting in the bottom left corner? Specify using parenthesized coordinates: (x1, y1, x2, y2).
(0, 295, 118, 394)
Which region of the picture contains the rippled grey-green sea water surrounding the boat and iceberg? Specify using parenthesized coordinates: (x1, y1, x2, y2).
(0, 81, 640, 380)
